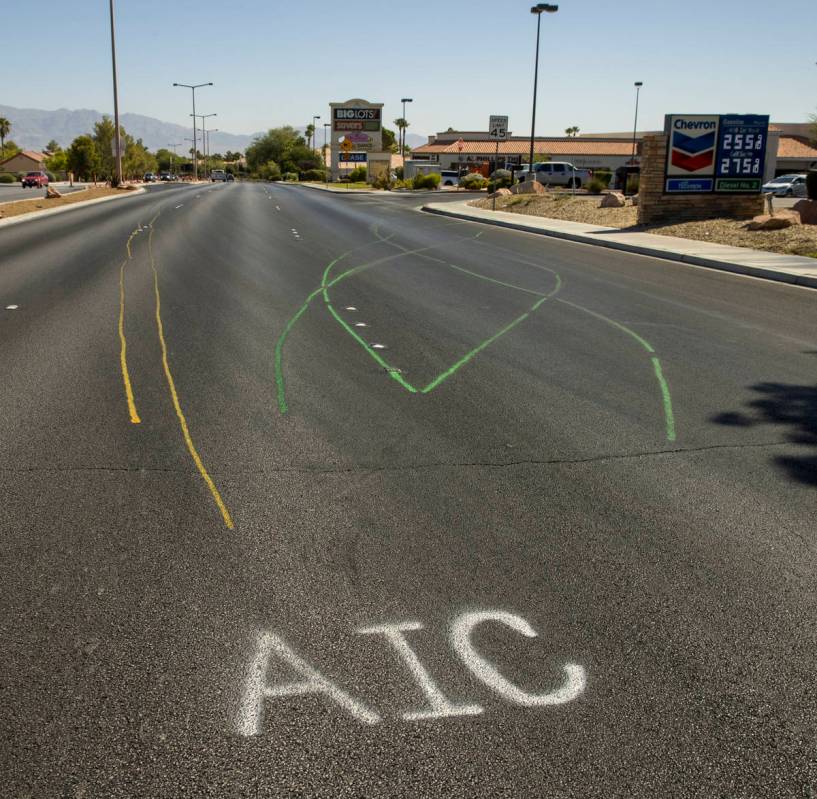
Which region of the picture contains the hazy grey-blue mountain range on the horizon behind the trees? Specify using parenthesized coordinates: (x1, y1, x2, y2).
(0, 105, 427, 153)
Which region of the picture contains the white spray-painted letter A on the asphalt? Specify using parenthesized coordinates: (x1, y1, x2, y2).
(235, 633, 380, 736)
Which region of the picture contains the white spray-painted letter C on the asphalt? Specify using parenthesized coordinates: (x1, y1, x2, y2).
(451, 610, 587, 707)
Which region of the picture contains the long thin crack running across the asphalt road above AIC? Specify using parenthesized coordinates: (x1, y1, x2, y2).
(0, 441, 797, 475)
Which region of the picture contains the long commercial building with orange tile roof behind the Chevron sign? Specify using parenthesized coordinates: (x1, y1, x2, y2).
(406, 123, 817, 177)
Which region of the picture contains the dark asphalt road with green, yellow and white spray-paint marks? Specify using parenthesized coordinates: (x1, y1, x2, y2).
(0, 178, 817, 799)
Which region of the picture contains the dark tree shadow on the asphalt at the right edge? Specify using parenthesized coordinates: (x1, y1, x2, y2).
(713, 383, 817, 487)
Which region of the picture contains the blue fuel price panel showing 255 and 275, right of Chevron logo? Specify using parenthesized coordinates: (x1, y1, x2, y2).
(715, 114, 769, 194)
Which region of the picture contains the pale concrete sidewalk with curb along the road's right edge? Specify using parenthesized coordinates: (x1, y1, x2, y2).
(423, 202, 817, 288)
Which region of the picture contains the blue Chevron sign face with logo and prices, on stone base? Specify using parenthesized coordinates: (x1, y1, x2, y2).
(665, 114, 769, 194)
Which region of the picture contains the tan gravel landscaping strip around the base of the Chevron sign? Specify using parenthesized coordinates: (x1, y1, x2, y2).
(472, 195, 817, 258)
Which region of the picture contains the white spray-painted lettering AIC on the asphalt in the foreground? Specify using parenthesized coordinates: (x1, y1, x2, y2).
(235, 610, 587, 736)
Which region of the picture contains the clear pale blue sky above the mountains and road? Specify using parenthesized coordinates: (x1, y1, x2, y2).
(7, 0, 817, 134)
